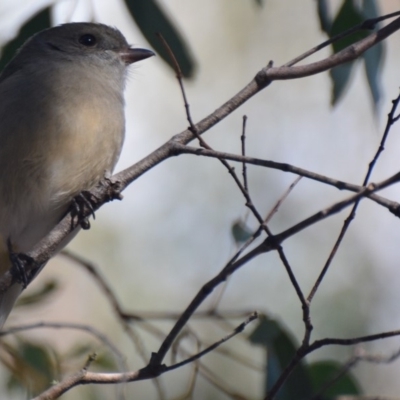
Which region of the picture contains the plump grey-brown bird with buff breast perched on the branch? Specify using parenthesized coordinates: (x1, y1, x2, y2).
(0, 22, 154, 329)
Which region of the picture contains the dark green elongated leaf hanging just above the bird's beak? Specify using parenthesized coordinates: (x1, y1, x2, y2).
(125, 0, 195, 77)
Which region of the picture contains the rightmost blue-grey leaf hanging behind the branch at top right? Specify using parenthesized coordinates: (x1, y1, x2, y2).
(362, 0, 384, 106)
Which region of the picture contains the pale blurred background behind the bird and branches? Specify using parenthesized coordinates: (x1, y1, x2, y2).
(0, 0, 400, 400)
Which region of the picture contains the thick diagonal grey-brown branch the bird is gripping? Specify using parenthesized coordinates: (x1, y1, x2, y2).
(0, 11, 400, 292)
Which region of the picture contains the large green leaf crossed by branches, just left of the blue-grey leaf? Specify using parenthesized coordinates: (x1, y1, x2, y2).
(329, 0, 368, 105)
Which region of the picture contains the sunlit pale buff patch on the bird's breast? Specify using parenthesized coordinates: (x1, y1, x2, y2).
(46, 93, 125, 202)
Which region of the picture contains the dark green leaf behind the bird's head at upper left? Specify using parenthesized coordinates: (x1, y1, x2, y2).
(0, 7, 50, 71)
